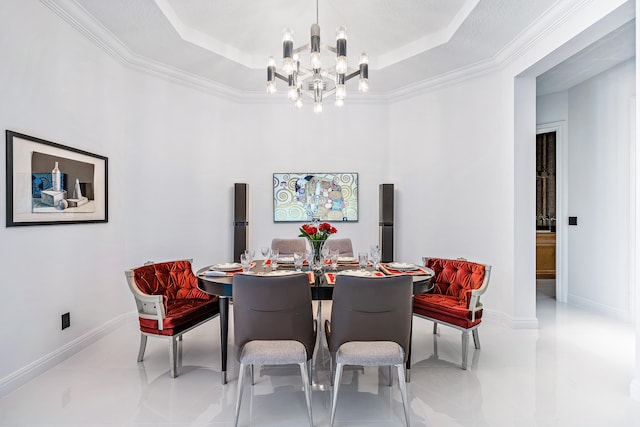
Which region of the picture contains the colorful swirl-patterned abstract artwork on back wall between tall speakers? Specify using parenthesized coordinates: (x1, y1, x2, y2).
(273, 172, 358, 222)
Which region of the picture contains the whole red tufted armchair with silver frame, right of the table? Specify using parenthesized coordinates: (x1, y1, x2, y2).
(413, 258, 491, 369)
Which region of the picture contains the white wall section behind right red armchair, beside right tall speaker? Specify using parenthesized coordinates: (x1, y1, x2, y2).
(389, 75, 513, 320)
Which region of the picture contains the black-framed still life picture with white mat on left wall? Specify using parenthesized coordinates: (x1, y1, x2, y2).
(6, 130, 109, 227)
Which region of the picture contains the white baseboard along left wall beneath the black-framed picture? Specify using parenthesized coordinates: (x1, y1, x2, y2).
(0, 312, 136, 397)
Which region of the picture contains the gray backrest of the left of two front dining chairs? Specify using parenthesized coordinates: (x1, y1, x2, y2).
(233, 273, 315, 360)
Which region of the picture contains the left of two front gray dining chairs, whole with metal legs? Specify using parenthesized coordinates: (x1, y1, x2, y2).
(233, 273, 316, 426)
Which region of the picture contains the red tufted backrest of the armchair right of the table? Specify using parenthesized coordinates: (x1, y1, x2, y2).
(425, 258, 489, 307)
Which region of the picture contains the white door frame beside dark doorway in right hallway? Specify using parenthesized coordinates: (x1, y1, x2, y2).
(534, 121, 569, 302)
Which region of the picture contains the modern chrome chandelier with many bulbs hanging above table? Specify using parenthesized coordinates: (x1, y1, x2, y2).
(267, 0, 369, 113)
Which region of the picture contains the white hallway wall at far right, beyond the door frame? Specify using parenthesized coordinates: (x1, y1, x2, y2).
(568, 60, 635, 319)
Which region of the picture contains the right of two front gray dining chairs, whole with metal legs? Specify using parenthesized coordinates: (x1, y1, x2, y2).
(325, 275, 413, 426)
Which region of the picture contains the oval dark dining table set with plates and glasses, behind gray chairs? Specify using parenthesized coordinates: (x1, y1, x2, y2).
(196, 259, 435, 384)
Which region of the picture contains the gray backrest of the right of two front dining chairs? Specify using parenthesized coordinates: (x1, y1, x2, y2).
(327, 275, 413, 361)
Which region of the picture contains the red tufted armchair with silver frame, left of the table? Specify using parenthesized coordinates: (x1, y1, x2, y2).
(124, 260, 220, 378)
